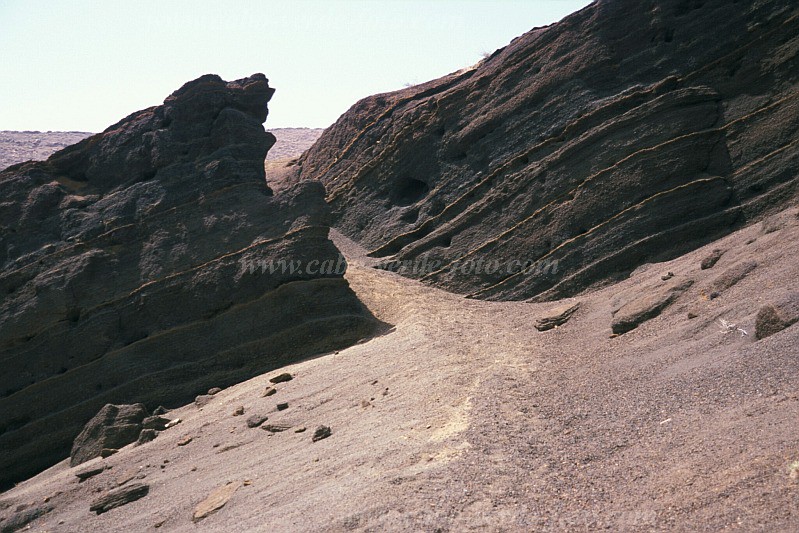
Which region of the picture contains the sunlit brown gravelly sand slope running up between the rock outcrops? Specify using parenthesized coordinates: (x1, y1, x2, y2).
(0, 209, 799, 532)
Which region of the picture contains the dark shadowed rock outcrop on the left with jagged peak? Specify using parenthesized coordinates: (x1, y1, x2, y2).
(0, 74, 373, 486)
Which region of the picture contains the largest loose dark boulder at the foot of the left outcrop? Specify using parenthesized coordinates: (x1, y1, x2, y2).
(69, 403, 147, 466)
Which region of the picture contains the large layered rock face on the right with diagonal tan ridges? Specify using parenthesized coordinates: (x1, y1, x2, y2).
(295, 0, 799, 299)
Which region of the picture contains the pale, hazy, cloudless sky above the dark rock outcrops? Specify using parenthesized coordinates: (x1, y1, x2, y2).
(0, 0, 590, 132)
